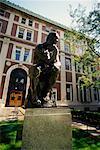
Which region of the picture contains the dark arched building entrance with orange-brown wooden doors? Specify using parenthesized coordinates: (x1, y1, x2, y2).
(6, 68, 27, 106)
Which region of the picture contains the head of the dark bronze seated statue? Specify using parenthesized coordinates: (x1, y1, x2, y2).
(46, 32, 59, 45)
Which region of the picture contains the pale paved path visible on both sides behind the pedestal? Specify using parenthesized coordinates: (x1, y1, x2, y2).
(0, 107, 100, 136)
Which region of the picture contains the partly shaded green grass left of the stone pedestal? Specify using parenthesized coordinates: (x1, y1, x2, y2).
(0, 121, 23, 150)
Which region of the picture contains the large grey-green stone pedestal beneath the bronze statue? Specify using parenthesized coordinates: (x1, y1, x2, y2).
(22, 107, 72, 150)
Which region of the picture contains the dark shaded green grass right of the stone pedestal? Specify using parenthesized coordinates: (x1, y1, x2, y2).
(73, 129, 100, 150)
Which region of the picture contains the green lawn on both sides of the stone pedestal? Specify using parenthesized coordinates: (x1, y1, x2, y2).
(0, 121, 100, 150)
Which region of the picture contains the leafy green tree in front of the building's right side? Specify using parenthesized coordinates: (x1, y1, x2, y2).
(65, 2, 100, 87)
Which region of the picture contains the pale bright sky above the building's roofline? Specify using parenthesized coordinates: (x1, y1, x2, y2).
(9, 0, 96, 27)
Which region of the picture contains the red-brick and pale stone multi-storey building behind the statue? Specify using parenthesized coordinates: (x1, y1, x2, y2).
(0, 0, 100, 110)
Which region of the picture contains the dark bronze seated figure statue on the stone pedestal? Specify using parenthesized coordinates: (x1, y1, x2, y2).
(27, 32, 61, 107)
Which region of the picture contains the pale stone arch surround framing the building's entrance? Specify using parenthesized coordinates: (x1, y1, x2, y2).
(2, 64, 30, 107)
